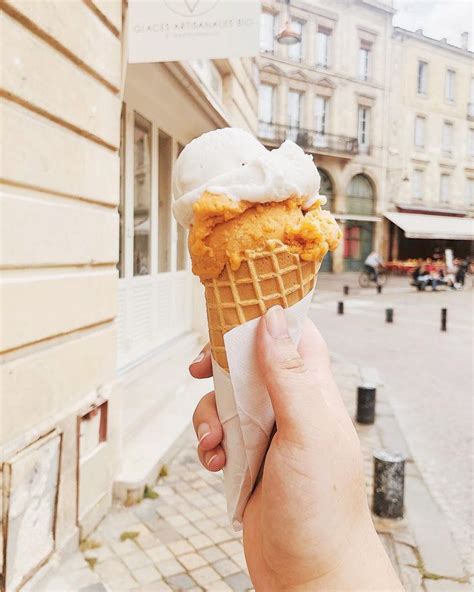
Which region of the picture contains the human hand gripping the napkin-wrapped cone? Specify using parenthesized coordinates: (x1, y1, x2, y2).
(190, 307, 401, 592)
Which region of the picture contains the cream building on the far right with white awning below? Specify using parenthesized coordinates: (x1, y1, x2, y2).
(385, 28, 474, 259)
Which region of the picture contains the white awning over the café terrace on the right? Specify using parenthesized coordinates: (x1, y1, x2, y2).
(384, 212, 474, 240)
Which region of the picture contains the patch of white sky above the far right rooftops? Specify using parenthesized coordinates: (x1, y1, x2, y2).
(393, 0, 474, 51)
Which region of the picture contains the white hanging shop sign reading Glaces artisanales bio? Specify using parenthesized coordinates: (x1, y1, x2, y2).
(128, 0, 260, 64)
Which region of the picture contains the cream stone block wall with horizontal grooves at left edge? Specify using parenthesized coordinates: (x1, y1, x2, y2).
(0, 0, 122, 590)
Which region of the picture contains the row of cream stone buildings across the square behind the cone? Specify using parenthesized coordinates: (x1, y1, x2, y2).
(259, 0, 474, 271)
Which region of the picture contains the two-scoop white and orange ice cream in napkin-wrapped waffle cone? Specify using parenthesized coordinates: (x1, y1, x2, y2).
(174, 128, 340, 527)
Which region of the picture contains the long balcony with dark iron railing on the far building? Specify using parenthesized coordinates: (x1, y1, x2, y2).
(258, 121, 359, 158)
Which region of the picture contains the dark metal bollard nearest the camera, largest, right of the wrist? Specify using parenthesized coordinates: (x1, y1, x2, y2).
(372, 450, 405, 518)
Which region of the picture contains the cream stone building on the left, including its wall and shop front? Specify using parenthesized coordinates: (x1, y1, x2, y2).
(0, 0, 257, 592)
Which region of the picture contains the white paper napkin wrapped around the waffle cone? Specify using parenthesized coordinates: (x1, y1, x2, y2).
(212, 290, 313, 530)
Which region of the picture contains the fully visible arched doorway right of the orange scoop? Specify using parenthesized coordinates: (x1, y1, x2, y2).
(344, 174, 375, 271)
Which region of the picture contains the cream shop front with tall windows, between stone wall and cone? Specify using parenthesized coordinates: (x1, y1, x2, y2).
(114, 60, 253, 503)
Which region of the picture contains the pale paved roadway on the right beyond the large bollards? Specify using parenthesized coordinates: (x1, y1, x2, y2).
(310, 274, 473, 567)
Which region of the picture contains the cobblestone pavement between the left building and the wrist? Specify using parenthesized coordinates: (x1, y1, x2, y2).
(35, 433, 252, 592)
